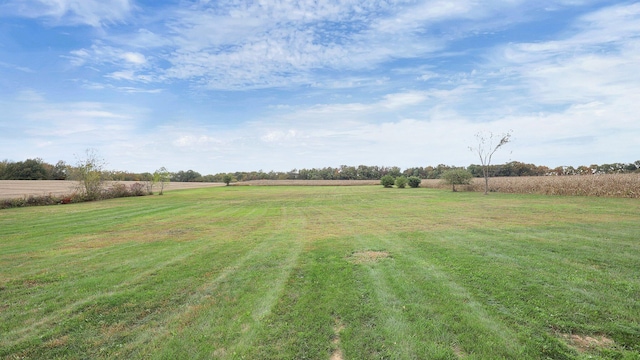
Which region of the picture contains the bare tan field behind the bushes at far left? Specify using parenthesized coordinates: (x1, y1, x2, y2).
(0, 180, 224, 199)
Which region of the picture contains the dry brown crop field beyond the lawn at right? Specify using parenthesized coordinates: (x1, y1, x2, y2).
(420, 173, 640, 198)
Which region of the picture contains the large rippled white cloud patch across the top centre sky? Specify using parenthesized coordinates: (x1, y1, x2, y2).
(63, 0, 536, 90)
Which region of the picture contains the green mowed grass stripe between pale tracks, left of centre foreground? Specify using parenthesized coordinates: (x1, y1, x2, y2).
(130, 205, 305, 359)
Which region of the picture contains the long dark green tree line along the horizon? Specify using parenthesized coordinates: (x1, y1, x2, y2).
(0, 158, 640, 182)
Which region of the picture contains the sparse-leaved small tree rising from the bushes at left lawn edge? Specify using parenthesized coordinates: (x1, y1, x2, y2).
(73, 149, 106, 200)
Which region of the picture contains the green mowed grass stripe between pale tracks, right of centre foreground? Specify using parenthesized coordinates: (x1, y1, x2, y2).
(371, 233, 524, 359)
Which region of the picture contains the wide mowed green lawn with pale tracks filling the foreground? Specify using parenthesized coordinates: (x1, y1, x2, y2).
(0, 186, 640, 359)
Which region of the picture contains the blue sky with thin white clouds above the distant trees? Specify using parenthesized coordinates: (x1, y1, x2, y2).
(0, 0, 640, 175)
